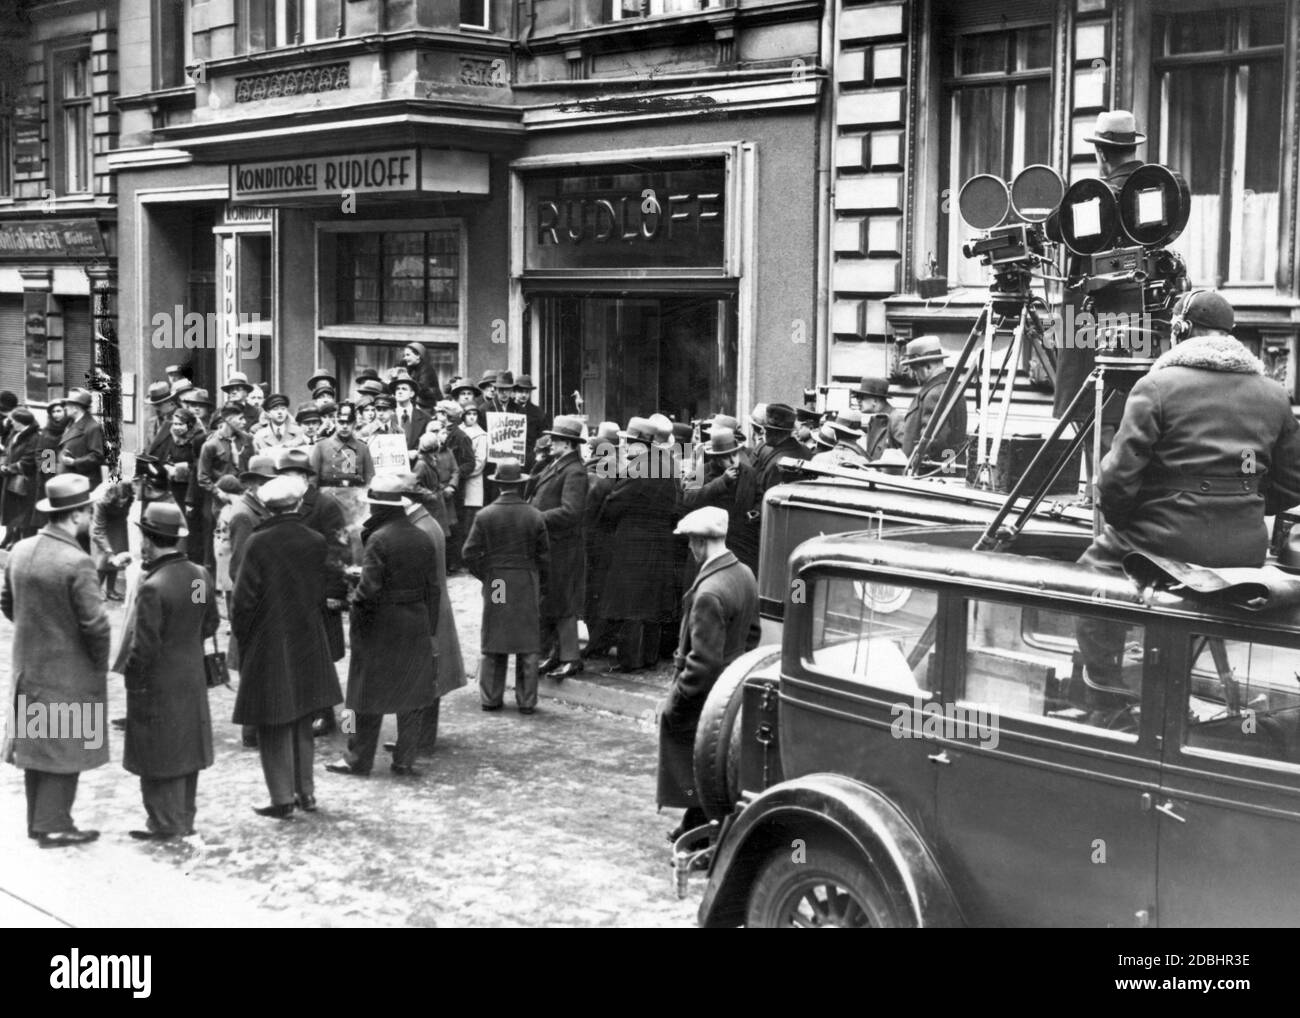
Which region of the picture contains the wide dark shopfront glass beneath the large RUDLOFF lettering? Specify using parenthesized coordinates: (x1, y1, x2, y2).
(530, 293, 737, 425)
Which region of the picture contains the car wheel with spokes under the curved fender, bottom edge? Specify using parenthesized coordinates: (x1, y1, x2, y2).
(745, 842, 913, 930)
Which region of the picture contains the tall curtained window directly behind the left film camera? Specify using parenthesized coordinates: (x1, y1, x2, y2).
(939, 25, 1052, 286)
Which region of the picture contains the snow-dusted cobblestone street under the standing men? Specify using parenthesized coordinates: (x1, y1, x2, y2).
(0, 577, 698, 927)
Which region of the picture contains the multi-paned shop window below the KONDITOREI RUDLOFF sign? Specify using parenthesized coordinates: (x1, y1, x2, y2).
(335, 229, 460, 326)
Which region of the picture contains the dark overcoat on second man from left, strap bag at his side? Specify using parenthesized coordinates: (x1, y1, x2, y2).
(122, 551, 220, 779)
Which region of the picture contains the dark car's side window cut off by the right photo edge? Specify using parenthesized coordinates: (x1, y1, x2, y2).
(1183, 634, 1300, 766)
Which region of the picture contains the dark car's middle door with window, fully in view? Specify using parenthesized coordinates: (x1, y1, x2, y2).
(927, 597, 1162, 927)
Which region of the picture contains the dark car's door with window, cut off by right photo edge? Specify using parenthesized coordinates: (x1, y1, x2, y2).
(1156, 624, 1300, 927)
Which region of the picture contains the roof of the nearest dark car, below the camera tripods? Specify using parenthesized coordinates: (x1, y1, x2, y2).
(790, 527, 1300, 633)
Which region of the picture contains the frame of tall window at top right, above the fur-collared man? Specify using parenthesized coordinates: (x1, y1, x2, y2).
(1148, 0, 1288, 289)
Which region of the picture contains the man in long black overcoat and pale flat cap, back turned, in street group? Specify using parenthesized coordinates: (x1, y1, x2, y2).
(230, 477, 343, 819)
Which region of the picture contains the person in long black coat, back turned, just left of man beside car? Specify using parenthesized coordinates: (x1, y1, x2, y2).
(601, 417, 677, 671)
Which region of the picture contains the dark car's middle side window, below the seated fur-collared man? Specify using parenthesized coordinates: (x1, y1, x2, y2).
(958, 598, 1145, 741)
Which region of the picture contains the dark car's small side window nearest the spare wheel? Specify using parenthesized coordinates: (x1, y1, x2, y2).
(806, 576, 939, 699)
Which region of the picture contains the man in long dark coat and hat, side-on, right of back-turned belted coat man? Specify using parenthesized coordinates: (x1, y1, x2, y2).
(528, 416, 586, 680)
